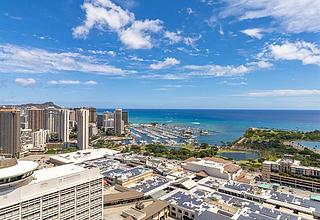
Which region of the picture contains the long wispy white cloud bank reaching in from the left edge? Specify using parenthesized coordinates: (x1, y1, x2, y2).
(0, 44, 129, 75)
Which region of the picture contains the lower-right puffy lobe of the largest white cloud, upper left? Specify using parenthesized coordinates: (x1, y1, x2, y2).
(119, 20, 162, 49)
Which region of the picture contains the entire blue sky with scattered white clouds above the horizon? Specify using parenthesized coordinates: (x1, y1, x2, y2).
(0, 0, 320, 109)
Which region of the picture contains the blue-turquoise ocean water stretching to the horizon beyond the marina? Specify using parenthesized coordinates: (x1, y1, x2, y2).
(97, 109, 320, 144)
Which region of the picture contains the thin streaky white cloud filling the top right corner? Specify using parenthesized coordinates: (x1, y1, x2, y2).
(220, 0, 320, 33)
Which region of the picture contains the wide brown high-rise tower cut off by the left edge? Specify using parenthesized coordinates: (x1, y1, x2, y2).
(0, 109, 21, 158)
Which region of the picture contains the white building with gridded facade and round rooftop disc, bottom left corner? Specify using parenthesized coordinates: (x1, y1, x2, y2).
(0, 158, 103, 220)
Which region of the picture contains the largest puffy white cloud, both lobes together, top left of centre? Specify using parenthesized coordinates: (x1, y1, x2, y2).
(73, 0, 162, 49)
